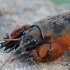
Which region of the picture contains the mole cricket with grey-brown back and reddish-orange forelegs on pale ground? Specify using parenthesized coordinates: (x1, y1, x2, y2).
(1, 12, 70, 68)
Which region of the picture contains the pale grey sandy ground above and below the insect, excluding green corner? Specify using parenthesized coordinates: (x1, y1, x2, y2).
(0, 0, 70, 70)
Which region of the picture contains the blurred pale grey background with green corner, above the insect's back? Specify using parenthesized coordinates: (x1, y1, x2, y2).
(0, 0, 70, 39)
